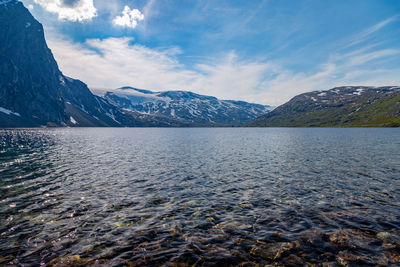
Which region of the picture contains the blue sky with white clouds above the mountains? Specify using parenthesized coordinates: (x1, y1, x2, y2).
(22, 0, 400, 106)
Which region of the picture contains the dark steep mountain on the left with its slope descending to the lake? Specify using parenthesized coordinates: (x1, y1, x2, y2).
(0, 0, 143, 127)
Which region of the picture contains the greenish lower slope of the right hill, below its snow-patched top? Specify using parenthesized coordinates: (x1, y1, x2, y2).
(249, 92, 400, 127)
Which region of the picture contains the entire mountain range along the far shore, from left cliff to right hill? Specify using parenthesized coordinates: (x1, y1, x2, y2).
(0, 0, 400, 128)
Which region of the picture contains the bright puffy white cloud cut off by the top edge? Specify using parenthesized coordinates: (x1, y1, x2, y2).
(34, 0, 97, 22)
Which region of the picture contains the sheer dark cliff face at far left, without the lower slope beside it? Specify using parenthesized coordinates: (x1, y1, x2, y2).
(0, 1, 68, 126)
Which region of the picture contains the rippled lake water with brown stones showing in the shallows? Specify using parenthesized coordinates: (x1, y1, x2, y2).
(0, 128, 400, 266)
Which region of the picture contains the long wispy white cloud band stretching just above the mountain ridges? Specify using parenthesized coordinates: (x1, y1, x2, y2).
(49, 34, 400, 105)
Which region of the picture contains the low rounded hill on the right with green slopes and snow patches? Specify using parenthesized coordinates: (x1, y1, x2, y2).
(249, 86, 400, 127)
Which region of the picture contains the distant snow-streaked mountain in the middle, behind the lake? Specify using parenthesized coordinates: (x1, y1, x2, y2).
(104, 87, 271, 126)
